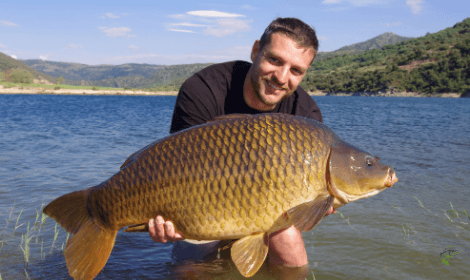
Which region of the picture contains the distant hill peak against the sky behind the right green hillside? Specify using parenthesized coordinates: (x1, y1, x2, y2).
(315, 32, 413, 62)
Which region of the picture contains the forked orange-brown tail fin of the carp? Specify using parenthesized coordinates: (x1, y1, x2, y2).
(43, 189, 117, 279)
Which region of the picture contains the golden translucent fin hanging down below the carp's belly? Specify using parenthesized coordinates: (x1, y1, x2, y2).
(231, 232, 269, 277)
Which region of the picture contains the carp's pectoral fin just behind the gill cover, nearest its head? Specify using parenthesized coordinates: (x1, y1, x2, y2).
(287, 195, 335, 231)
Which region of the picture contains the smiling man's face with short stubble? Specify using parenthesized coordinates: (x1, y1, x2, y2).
(248, 33, 314, 110)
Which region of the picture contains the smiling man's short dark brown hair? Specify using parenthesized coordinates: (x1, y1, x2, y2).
(259, 18, 318, 56)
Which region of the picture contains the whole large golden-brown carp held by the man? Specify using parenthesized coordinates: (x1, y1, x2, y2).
(44, 114, 398, 279)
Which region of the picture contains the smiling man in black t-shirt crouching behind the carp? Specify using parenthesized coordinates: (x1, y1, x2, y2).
(149, 18, 334, 267)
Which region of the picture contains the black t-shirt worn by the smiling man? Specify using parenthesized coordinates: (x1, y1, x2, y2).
(170, 61, 323, 133)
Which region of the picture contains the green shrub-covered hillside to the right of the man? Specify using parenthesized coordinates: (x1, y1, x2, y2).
(301, 18, 470, 96)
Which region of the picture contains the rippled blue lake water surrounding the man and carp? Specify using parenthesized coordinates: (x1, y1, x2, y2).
(0, 95, 470, 279)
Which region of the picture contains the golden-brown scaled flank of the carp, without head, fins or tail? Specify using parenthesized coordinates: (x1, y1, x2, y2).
(92, 116, 327, 236)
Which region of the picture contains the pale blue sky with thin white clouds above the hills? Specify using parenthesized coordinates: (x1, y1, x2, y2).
(0, 0, 470, 65)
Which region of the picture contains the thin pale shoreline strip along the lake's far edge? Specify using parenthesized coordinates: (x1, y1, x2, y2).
(0, 85, 461, 98)
